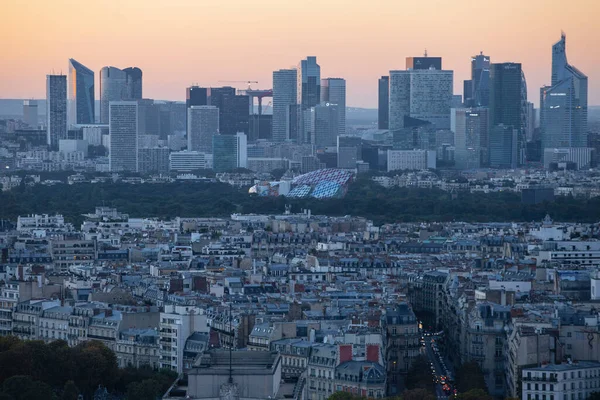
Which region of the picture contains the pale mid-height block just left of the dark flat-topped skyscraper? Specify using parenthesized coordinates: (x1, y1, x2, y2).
(450, 108, 488, 169)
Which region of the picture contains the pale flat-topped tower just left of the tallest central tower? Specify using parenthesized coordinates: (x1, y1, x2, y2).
(273, 69, 297, 142)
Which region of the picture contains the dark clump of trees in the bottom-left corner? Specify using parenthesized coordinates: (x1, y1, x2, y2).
(0, 336, 177, 400)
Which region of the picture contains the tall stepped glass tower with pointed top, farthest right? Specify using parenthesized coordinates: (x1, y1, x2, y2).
(540, 32, 588, 152)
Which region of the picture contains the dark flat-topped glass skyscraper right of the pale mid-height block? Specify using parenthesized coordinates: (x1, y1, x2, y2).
(489, 63, 527, 164)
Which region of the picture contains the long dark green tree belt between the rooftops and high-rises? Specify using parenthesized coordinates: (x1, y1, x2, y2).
(0, 178, 600, 224)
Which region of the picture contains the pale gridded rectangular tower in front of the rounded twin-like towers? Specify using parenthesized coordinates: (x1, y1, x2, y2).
(108, 101, 139, 172)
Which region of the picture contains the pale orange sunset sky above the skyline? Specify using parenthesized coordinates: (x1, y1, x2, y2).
(0, 0, 600, 107)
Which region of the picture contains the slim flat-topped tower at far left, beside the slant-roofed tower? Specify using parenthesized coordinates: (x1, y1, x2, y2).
(46, 75, 67, 150)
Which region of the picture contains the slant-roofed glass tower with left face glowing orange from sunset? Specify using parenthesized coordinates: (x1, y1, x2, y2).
(67, 58, 96, 125)
